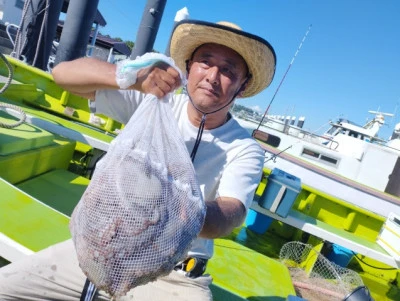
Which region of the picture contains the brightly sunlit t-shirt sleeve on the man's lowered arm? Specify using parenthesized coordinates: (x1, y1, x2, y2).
(218, 141, 264, 210)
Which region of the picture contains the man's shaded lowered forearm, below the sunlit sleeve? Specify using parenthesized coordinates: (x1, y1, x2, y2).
(199, 197, 246, 238)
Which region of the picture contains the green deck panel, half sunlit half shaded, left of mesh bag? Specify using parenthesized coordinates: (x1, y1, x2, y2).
(0, 170, 89, 252)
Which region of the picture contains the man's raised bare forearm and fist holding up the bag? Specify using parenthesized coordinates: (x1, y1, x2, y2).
(52, 57, 180, 99)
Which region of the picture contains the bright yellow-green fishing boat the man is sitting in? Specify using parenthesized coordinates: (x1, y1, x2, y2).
(0, 1, 400, 301)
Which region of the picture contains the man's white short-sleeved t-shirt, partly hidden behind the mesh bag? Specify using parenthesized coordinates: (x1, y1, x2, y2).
(95, 90, 264, 258)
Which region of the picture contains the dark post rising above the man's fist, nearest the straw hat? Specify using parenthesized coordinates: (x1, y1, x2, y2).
(130, 0, 167, 59)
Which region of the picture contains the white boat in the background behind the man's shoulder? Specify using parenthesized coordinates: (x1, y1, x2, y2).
(237, 111, 400, 217)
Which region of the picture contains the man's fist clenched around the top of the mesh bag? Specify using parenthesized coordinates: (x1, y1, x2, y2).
(136, 62, 181, 98)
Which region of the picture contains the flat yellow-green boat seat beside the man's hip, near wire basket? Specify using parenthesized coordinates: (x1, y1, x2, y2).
(206, 239, 296, 301)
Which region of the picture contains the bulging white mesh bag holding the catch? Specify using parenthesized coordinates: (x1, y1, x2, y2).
(70, 95, 205, 297)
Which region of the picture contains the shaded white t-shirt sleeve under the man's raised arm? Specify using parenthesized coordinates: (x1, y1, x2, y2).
(94, 90, 145, 124)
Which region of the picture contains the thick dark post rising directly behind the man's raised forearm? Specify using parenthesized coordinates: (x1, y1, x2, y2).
(52, 0, 99, 65)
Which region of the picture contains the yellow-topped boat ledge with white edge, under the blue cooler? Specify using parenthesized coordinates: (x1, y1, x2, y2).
(251, 201, 400, 268)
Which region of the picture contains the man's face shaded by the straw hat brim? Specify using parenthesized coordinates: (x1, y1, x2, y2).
(187, 44, 247, 113)
